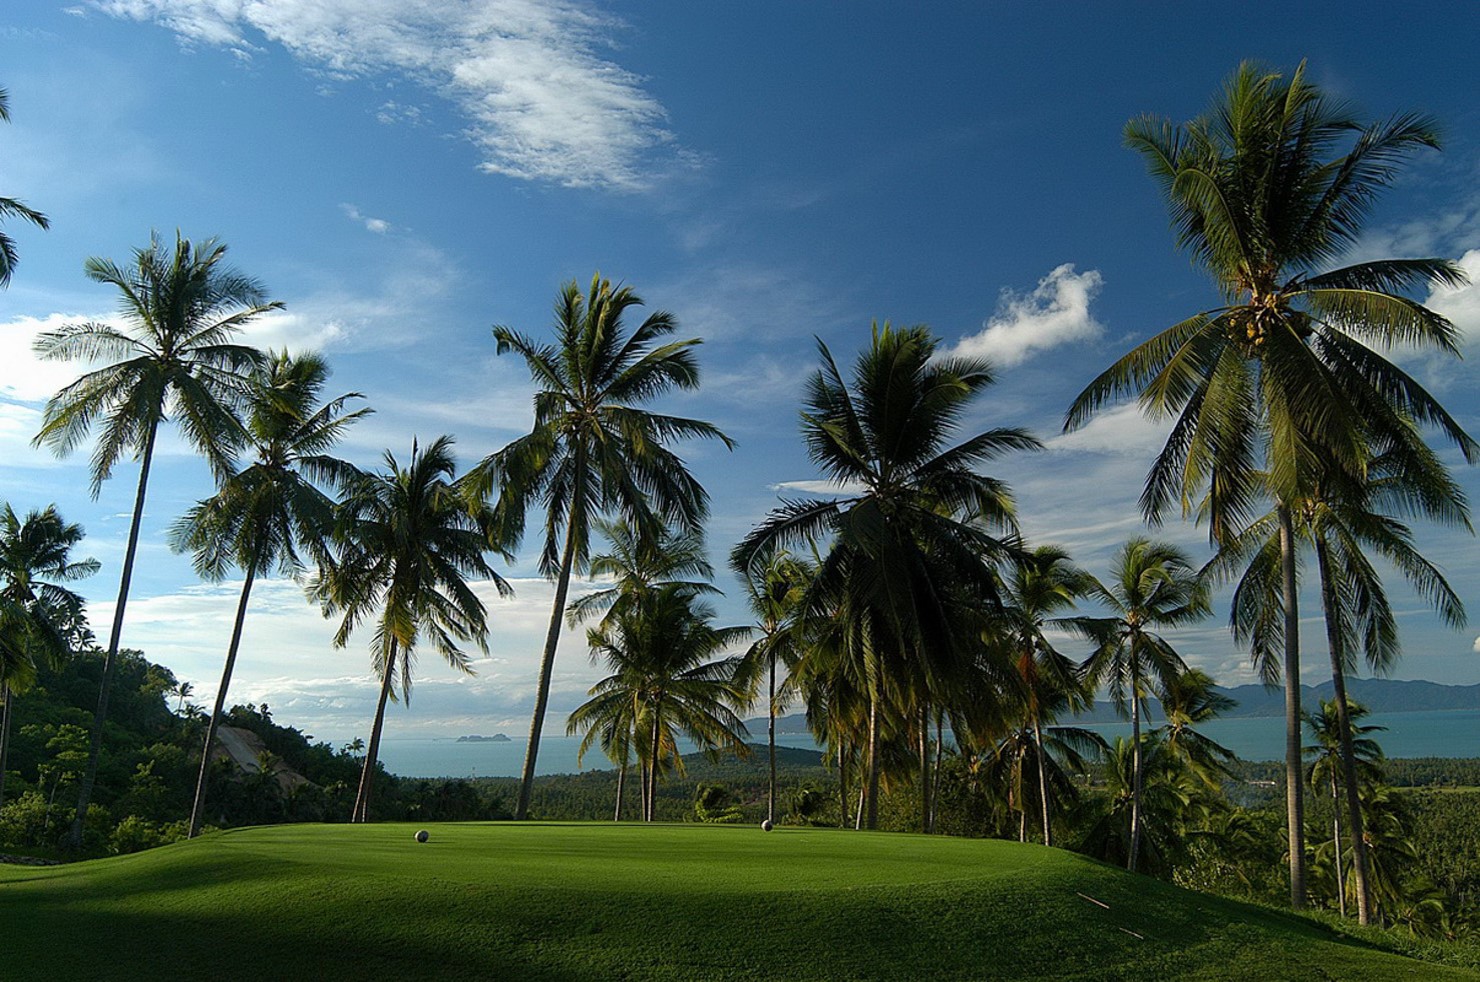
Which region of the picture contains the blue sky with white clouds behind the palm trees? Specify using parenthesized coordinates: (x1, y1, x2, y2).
(0, 0, 1480, 739)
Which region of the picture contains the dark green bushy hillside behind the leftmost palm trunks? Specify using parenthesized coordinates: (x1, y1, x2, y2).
(0, 649, 506, 858)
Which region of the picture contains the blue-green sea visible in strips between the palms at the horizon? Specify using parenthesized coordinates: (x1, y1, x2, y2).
(380, 710, 1480, 778)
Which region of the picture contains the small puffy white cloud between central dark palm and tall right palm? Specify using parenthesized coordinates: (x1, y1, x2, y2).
(949, 263, 1104, 367)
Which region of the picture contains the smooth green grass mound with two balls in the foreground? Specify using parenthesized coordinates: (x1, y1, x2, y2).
(0, 824, 1480, 982)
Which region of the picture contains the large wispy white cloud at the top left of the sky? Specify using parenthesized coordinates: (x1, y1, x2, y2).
(95, 0, 684, 191)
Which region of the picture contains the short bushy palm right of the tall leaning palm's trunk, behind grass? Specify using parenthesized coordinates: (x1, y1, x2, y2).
(568, 584, 750, 822)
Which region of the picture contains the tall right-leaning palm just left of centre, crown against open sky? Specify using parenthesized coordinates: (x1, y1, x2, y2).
(468, 274, 734, 819)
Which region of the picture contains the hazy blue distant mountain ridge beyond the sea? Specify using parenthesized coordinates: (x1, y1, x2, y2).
(746, 679, 1480, 741)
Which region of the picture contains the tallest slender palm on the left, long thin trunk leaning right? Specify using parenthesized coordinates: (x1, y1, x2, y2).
(33, 234, 283, 847)
